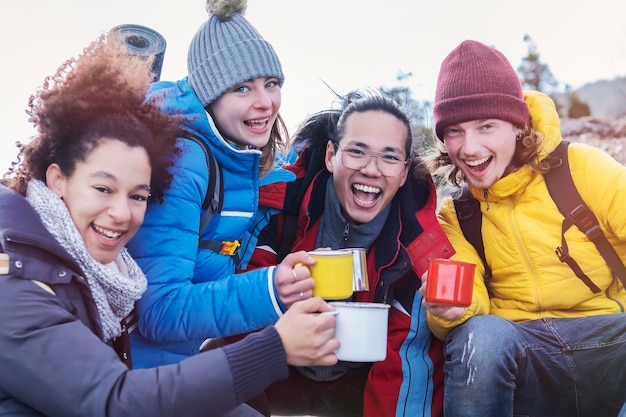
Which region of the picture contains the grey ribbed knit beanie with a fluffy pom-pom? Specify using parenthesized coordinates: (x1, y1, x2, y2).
(187, 0, 285, 107)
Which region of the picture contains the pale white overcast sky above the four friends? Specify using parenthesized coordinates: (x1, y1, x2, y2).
(0, 0, 626, 172)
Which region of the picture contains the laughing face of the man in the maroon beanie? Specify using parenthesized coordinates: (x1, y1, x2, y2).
(443, 119, 522, 188)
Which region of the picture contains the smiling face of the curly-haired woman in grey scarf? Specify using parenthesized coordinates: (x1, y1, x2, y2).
(46, 139, 151, 264)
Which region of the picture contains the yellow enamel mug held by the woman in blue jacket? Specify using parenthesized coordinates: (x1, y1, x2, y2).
(309, 250, 353, 300)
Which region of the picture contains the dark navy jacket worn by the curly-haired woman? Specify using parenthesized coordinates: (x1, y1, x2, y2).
(0, 185, 287, 417)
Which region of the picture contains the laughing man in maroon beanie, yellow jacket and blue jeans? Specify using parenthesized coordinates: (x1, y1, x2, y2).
(420, 41, 626, 417)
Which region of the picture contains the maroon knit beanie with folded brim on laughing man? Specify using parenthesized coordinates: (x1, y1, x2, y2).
(434, 40, 530, 140)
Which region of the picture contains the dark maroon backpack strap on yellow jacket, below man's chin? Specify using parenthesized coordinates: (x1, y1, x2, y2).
(452, 185, 491, 296)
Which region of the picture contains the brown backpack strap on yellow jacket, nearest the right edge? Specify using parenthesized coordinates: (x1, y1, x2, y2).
(544, 141, 626, 293)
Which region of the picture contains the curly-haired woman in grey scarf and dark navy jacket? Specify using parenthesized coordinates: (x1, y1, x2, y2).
(0, 30, 338, 417)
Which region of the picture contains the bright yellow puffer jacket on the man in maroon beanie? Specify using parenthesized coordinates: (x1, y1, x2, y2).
(428, 91, 626, 339)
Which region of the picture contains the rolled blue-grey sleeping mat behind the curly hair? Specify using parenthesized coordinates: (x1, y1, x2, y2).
(110, 24, 166, 81)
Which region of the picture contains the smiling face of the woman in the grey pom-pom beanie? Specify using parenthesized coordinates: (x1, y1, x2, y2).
(210, 77, 281, 148)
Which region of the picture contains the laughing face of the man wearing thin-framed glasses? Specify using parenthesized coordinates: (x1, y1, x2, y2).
(326, 110, 409, 223)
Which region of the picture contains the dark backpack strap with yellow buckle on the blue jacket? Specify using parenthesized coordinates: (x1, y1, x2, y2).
(187, 136, 241, 265)
